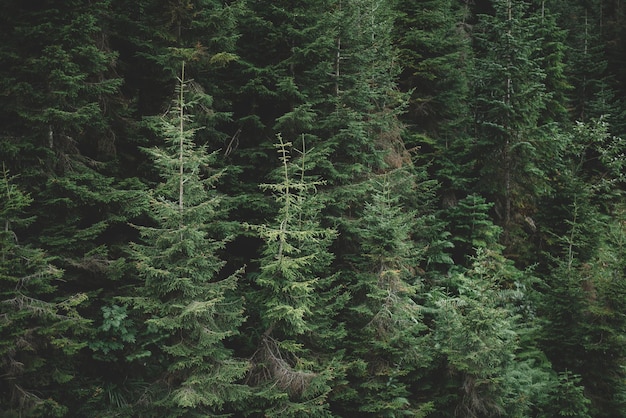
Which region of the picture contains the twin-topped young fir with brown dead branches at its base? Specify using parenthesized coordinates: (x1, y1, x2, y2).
(246, 135, 345, 417)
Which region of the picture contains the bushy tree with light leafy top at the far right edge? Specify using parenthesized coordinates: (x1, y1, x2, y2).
(542, 121, 624, 417)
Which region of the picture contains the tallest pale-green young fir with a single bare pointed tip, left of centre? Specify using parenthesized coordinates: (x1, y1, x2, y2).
(121, 64, 247, 417)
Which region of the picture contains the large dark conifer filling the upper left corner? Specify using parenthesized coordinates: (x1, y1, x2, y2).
(0, 0, 140, 414)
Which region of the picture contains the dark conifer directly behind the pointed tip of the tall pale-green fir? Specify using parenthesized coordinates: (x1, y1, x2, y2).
(109, 0, 243, 190)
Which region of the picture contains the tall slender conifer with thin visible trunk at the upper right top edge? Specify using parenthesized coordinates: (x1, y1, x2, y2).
(473, 0, 551, 253)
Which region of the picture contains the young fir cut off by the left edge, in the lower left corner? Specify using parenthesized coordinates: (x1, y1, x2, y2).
(0, 165, 87, 417)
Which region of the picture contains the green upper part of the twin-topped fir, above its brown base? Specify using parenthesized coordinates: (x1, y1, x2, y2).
(247, 135, 336, 335)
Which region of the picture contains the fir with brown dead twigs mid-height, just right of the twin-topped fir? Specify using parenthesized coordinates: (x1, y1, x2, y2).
(326, 169, 432, 417)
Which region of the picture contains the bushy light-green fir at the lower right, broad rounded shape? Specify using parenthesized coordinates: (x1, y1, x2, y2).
(434, 249, 551, 417)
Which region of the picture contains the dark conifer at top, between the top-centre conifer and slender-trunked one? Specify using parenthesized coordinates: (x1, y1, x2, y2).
(394, 0, 472, 198)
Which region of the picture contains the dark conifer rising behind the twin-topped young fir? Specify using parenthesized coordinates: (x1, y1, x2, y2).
(223, 0, 336, 232)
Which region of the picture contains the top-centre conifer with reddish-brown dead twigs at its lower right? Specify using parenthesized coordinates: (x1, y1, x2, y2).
(319, 0, 410, 185)
